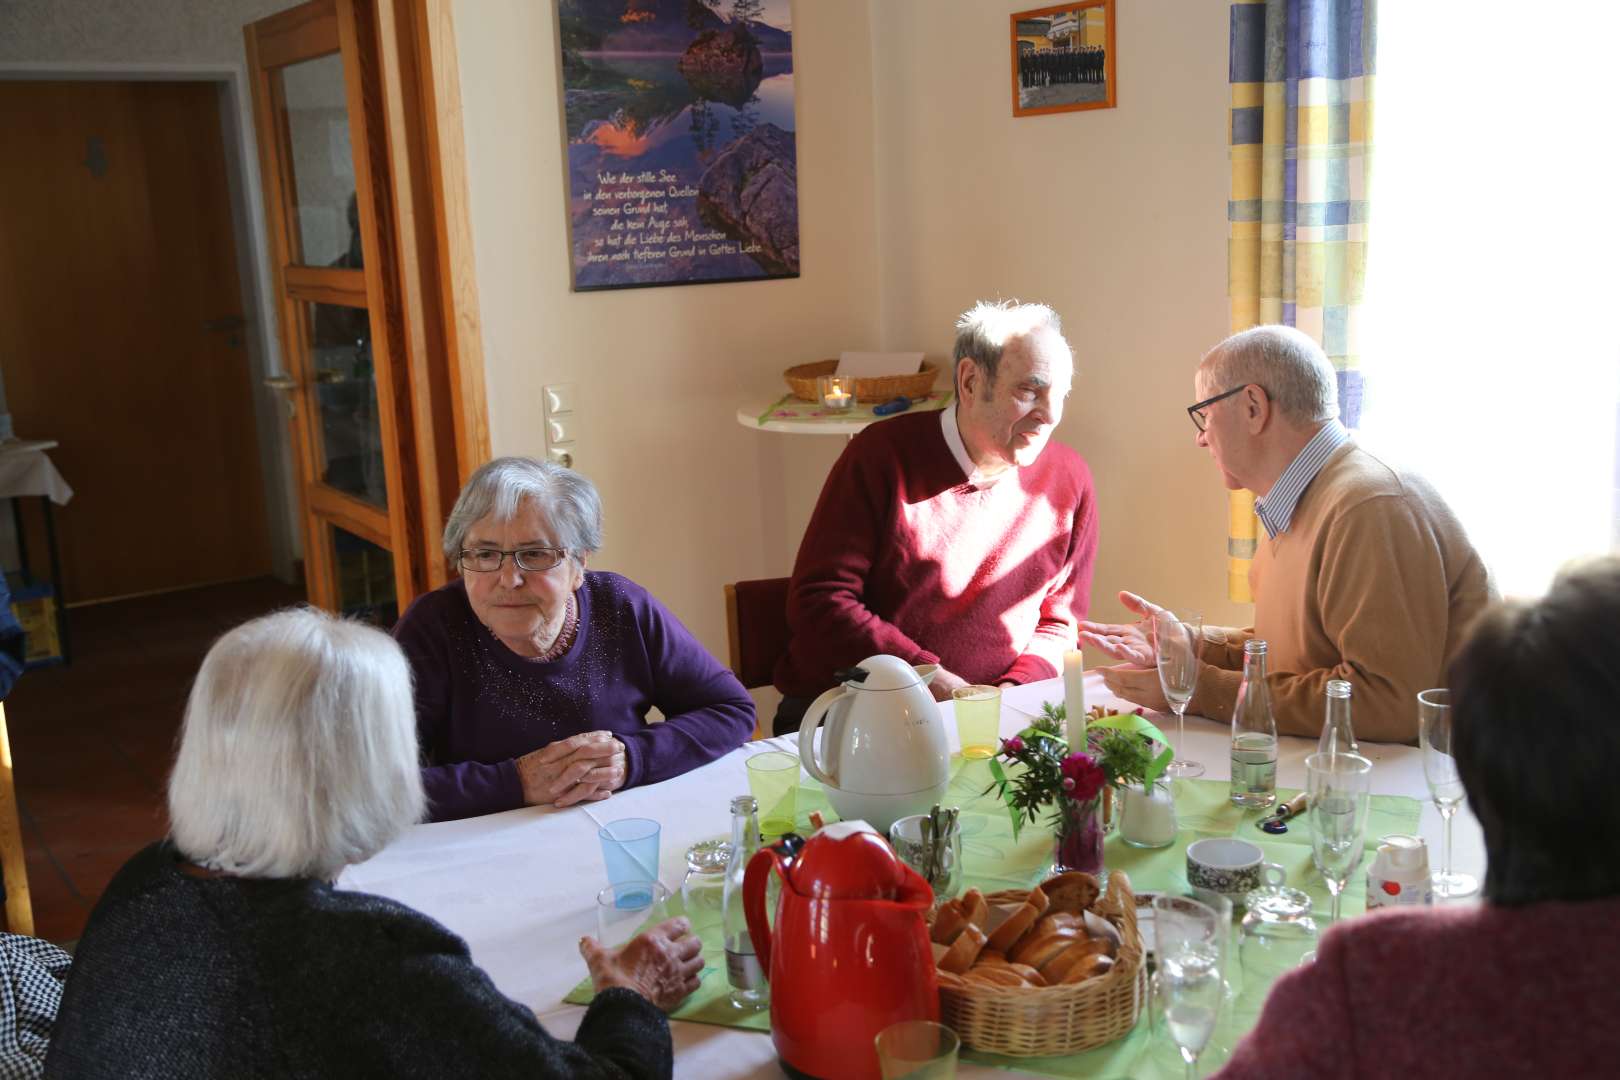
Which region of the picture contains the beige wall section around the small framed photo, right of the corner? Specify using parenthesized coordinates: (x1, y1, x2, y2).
(872, 0, 1247, 622)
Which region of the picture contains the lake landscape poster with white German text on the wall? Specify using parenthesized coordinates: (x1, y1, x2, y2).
(559, 0, 799, 291)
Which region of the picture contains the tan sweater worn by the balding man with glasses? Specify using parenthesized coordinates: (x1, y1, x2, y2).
(1187, 442, 1490, 743)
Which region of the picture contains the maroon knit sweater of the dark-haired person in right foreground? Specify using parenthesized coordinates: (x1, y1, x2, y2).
(1218, 893, 1620, 1080)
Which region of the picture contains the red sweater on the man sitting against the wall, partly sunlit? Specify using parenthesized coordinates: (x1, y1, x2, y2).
(776, 413, 1097, 696)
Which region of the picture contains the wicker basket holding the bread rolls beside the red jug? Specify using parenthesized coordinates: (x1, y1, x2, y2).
(940, 871, 1147, 1057)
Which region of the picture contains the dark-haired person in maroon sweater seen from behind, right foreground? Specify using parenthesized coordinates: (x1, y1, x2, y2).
(1218, 557, 1620, 1080)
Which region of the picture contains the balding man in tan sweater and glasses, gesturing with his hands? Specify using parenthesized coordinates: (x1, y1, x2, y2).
(1081, 325, 1490, 742)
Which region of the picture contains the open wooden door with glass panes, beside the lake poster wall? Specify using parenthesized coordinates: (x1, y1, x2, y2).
(246, 0, 423, 625)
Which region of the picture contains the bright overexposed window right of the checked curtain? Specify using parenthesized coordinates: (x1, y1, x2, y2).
(1361, 0, 1620, 596)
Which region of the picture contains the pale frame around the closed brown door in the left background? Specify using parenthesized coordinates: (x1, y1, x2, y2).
(0, 62, 300, 581)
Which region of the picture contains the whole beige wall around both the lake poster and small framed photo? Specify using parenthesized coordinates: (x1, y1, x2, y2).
(455, 0, 1243, 693)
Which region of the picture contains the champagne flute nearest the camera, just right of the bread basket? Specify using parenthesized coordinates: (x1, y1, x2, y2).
(1153, 895, 1226, 1080)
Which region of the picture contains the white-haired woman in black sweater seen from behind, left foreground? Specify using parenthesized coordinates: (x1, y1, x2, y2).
(45, 609, 703, 1080)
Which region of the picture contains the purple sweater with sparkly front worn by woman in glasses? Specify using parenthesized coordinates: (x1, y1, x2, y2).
(394, 570, 753, 821)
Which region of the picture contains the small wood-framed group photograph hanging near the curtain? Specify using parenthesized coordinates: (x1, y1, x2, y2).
(1013, 0, 1116, 117)
